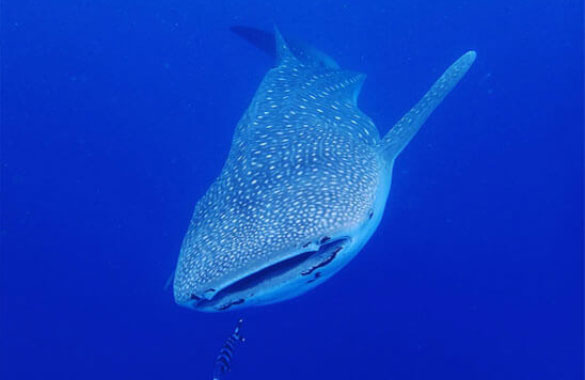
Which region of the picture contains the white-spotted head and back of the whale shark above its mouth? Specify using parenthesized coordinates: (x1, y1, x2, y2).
(174, 29, 474, 310)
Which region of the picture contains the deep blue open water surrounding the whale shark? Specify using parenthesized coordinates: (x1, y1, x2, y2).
(0, 0, 584, 380)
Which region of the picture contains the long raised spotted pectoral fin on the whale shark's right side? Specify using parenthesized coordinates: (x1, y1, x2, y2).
(381, 50, 476, 161)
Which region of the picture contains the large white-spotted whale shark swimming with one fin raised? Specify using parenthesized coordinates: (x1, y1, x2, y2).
(173, 29, 476, 312)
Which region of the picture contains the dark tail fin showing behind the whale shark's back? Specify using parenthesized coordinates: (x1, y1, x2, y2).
(230, 25, 339, 69)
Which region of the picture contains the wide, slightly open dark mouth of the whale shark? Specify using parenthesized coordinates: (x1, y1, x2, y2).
(191, 237, 350, 311)
